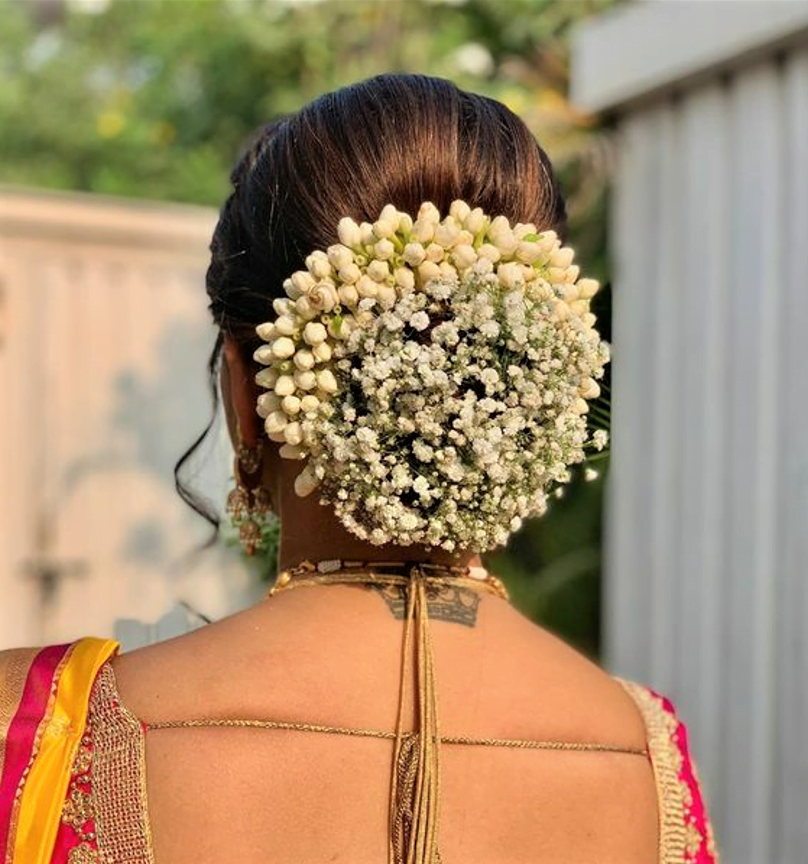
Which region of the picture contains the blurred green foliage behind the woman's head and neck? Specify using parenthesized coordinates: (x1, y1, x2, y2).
(0, 0, 617, 656)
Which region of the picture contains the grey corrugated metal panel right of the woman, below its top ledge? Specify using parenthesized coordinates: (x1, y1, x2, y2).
(605, 50, 808, 864)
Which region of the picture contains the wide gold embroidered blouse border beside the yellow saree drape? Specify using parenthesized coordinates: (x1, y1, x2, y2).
(91, 663, 154, 864)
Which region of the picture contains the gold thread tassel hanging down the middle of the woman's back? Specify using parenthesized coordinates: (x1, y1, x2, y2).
(388, 565, 440, 864)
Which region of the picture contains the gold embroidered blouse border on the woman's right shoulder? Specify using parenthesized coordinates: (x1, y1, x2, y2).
(618, 679, 688, 864)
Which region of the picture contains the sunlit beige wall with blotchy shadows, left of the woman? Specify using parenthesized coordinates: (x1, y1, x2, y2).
(0, 190, 255, 648)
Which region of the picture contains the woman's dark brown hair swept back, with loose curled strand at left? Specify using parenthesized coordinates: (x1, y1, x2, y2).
(175, 75, 566, 525)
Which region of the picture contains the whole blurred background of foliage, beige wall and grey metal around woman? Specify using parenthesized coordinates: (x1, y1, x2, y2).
(0, 0, 808, 864)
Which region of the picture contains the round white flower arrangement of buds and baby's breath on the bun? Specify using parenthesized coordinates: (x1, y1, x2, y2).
(254, 201, 609, 551)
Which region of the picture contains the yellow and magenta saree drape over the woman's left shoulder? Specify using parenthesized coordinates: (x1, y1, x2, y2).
(0, 638, 119, 864)
